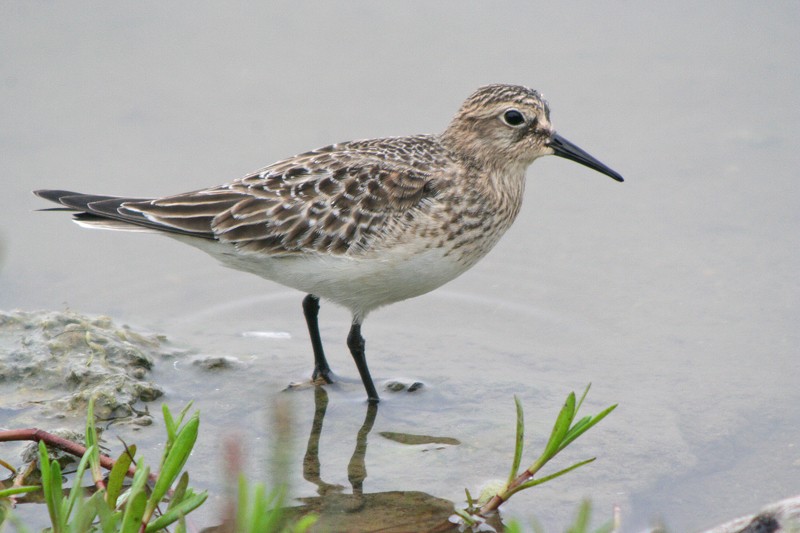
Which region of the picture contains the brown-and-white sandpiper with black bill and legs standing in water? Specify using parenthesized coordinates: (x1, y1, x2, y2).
(33, 84, 623, 403)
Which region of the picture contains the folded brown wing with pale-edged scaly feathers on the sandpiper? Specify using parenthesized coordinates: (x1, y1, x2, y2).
(122, 154, 436, 255)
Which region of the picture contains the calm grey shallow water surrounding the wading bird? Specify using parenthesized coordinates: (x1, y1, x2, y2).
(0, 2, 800, 531)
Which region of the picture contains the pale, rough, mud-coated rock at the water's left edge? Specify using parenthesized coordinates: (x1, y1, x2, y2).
(0, 311, 166, 420)
